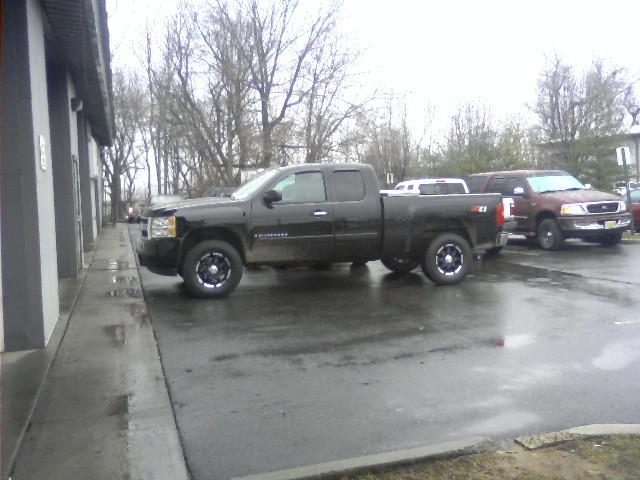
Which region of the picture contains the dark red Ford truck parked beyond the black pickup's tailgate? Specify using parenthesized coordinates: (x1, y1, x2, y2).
(466, 170, 630, 250)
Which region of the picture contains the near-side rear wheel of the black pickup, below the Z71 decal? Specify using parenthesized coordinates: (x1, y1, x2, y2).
(420, 233, 473, 285)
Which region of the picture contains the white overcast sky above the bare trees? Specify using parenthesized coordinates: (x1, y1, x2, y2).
(107, 0, 640, 135)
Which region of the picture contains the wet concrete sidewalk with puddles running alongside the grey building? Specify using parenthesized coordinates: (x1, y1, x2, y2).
(1, 224, 189, 480)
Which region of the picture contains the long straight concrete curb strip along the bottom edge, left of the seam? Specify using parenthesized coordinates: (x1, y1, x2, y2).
(232, 437, 490, 480)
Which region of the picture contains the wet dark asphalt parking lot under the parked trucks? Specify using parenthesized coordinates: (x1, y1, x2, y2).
(129, 225, 640, 480)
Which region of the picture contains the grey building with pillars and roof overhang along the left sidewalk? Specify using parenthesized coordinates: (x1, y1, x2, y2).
(0, 0, 114, 351)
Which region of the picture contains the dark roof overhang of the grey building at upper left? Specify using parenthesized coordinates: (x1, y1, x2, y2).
(42, 0, 115, 146)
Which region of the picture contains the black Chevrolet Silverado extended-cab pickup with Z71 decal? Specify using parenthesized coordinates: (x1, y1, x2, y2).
(136, 164, 507, 298)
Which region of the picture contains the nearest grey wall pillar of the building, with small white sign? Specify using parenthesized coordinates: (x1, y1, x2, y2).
(0, 0, 59, 350)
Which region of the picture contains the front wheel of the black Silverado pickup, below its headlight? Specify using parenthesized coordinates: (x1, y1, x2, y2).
(181, 240, 243, 298)
